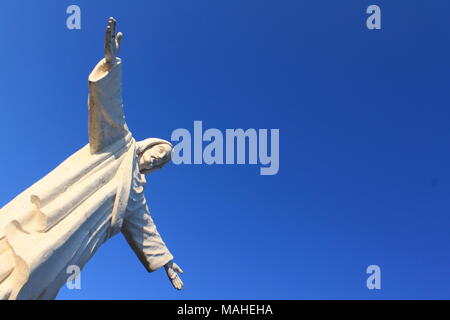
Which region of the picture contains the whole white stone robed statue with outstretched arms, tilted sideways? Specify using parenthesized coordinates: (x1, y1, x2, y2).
(0, 18, 183, 299)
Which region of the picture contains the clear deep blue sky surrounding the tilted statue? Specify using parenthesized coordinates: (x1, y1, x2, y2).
(0, 0, 450, 299)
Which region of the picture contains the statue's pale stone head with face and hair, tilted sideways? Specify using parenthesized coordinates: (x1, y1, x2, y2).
(137, 138, 173, 174)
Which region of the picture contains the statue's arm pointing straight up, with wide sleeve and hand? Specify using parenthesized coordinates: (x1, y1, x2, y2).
(88, 18, 129, 153)
